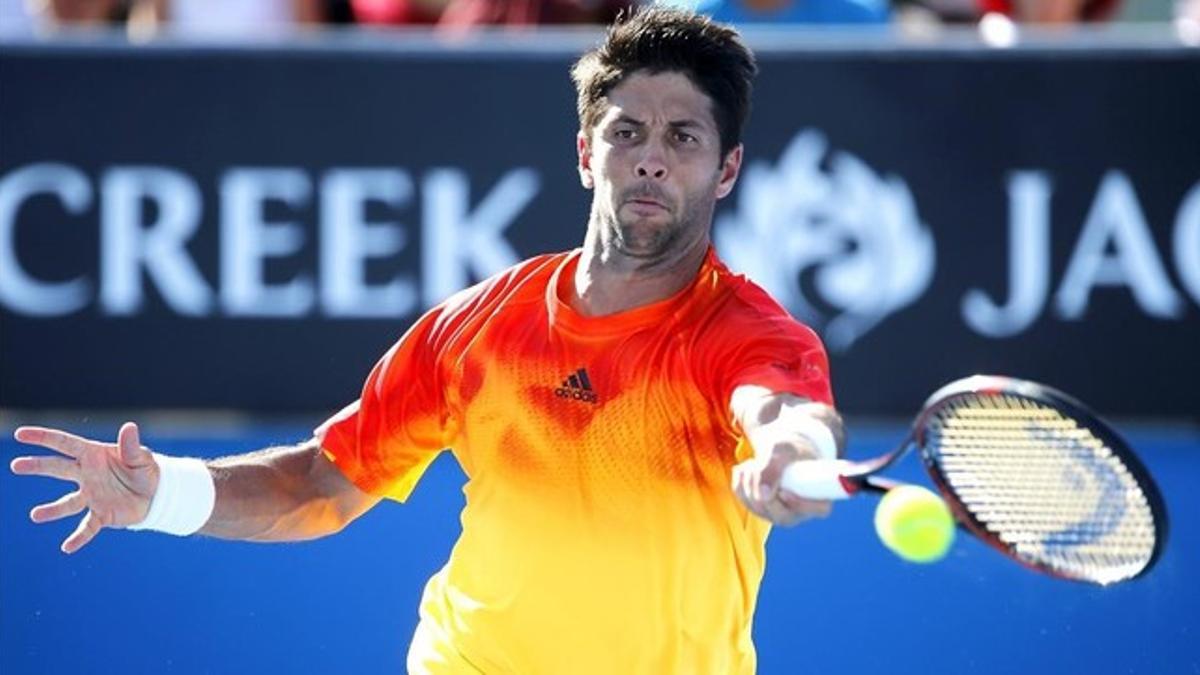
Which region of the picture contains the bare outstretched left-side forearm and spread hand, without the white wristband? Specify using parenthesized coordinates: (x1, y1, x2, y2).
(11, 423, 379, 552)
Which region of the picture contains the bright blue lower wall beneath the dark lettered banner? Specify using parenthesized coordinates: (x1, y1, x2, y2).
(0, 426, 1200, 675)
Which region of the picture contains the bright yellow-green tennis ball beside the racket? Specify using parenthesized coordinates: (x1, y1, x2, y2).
(875, 485, 954, 562)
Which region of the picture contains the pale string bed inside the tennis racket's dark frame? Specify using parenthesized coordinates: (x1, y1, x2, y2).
(925, 393, 1156, 583)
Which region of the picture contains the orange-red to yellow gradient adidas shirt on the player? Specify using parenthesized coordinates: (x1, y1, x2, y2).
(317, 250, 832, 675)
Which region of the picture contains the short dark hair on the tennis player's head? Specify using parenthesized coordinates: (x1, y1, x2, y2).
(571, 7, 758, 157)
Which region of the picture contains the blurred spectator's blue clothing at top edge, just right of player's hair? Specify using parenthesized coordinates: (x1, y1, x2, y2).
(660, 0, 890, 25)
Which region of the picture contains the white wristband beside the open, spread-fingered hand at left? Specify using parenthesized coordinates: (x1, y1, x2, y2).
(126, 453, 217, 537)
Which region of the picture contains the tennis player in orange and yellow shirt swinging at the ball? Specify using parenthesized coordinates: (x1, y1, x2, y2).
(12, 10, 842, 675)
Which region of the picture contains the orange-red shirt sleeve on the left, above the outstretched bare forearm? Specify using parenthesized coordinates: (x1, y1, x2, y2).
(316, 306, 449, 502)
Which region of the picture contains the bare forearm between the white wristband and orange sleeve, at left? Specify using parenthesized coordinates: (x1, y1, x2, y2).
(199, 438, 379, 542)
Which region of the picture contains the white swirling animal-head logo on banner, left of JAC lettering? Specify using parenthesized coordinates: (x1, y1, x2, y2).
(714, 130, 935, 352)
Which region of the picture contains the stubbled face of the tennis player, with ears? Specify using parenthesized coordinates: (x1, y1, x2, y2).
(577, 72, 742, 262)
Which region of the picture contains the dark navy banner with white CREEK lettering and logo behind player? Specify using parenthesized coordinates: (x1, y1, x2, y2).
(0, 43, 1200, 418)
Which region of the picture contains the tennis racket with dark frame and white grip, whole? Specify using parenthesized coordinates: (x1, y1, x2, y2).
(781, 376, 1168, 585)
